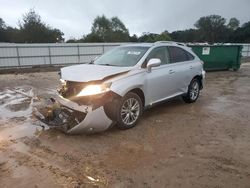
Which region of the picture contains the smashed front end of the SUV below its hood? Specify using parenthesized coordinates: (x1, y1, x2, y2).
(35, 81, 119, 134)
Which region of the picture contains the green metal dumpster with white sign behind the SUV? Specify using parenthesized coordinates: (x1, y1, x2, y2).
(189, 45, 242, 71)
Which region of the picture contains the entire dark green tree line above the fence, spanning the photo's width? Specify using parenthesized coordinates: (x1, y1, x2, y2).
(0, 10, 250, 43)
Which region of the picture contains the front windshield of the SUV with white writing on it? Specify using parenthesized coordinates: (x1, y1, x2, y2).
(94, 46, 149, 67)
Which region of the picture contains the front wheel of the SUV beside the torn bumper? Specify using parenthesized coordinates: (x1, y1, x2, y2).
(116, 92, 143, 129)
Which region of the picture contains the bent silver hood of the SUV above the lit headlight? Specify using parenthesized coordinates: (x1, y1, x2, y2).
(61, 64, 132, 82)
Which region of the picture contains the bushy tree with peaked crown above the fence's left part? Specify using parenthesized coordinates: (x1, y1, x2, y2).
(19, 10, 64, 43)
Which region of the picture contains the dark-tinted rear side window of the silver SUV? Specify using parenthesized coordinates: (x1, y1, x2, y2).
(168, 46, 194, 63)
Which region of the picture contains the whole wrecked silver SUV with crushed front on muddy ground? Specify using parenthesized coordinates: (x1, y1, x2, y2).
(36, 42, 205, 133)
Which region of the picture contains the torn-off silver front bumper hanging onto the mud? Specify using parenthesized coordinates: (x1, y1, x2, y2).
(34, 94, 113, 134)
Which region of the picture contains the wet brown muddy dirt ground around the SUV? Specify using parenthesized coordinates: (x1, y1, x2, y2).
(0, 63, 250, 188)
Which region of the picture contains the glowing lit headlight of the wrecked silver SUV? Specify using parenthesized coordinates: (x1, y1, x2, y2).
(76, 83, 111, 97)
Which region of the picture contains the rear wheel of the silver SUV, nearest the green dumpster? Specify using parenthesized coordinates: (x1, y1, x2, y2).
(182, 78, 200, 103)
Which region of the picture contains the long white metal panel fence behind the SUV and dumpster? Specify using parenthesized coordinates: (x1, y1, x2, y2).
(0, 43, 250, 69)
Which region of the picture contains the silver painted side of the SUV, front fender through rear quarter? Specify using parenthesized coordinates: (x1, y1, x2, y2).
(111, 45, 203, 106)
